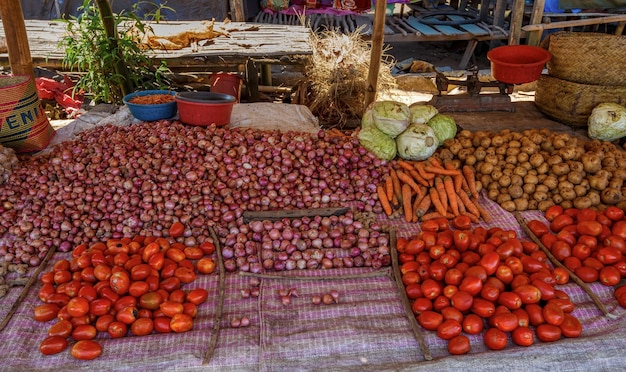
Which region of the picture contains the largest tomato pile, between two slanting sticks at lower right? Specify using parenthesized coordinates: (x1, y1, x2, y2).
(397, 216, 582, 354)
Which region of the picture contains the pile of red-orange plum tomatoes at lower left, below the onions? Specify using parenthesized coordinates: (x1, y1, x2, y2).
(34, 237, 215, 360)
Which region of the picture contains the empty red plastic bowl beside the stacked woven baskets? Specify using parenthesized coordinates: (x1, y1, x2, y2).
(487, 45, 552, 84)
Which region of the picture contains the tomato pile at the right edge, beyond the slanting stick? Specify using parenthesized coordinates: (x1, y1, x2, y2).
(528, 205, 626, 307)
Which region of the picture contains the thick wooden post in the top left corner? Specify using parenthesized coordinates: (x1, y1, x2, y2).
(0, 0, 35, 81)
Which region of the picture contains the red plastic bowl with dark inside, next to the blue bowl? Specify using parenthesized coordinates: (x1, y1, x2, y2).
(174, 92, 237, 127)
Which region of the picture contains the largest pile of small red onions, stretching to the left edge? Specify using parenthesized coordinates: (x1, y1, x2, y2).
(0, 120, 388, 266)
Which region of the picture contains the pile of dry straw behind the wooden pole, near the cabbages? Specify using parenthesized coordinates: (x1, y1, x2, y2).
(296, 30, 395, 129)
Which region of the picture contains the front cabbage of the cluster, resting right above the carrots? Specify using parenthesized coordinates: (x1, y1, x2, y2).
(396, 124, 439, 160)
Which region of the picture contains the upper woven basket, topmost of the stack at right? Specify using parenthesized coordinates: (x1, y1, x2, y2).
(547, 32, 626, 86)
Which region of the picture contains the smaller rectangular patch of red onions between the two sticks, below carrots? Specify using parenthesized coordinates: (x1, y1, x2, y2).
(218, 211, 391, 273)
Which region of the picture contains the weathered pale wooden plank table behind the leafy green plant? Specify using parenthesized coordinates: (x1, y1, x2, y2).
(0, 20, 312, 100)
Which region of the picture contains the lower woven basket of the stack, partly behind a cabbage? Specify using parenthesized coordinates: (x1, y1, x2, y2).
(535, 75, 626, 127)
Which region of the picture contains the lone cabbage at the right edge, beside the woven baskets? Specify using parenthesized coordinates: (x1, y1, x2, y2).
(587, 102, 626, 141)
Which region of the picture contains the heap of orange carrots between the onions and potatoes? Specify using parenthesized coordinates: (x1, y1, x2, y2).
(377, 158, 491, 222)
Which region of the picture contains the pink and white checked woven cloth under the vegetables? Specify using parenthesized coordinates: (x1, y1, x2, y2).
(0, 193, 626, 371)
